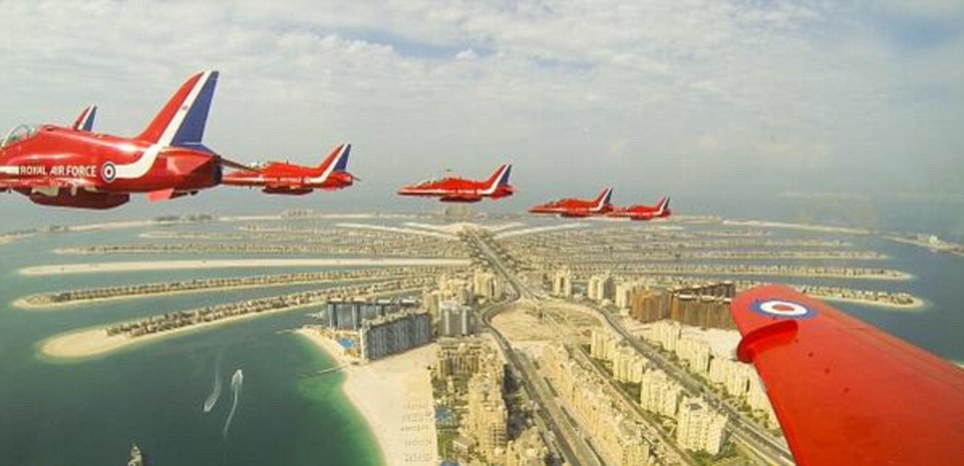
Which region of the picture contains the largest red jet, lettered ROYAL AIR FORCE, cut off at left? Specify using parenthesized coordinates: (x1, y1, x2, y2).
(0, 71, 252, 209)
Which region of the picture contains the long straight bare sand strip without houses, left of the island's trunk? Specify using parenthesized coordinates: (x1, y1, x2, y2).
(20, 257, 470, 275)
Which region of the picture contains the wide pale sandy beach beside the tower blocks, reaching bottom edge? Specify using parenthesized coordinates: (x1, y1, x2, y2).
(296, 329, 438, 466)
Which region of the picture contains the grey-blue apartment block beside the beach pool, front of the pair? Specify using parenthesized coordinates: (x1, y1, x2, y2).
(359, 310, 432, 361)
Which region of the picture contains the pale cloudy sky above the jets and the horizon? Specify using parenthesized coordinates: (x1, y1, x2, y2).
(0, 0, 964, 210)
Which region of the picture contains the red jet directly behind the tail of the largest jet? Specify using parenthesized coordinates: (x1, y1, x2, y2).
(221, 144, 361, 196)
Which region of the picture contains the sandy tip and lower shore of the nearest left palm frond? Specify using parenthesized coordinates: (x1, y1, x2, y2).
(40, 303, 332, 359)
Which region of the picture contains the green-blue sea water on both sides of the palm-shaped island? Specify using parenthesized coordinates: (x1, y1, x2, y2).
(0, 216, 964, 466)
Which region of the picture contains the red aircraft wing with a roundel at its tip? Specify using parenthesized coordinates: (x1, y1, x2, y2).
(730, 285, 964, 466)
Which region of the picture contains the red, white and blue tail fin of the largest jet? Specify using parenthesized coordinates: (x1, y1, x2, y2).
(137, 71, 218, 152)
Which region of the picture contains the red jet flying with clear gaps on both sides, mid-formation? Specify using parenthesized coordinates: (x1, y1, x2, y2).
(398, 165, 515, 202)
